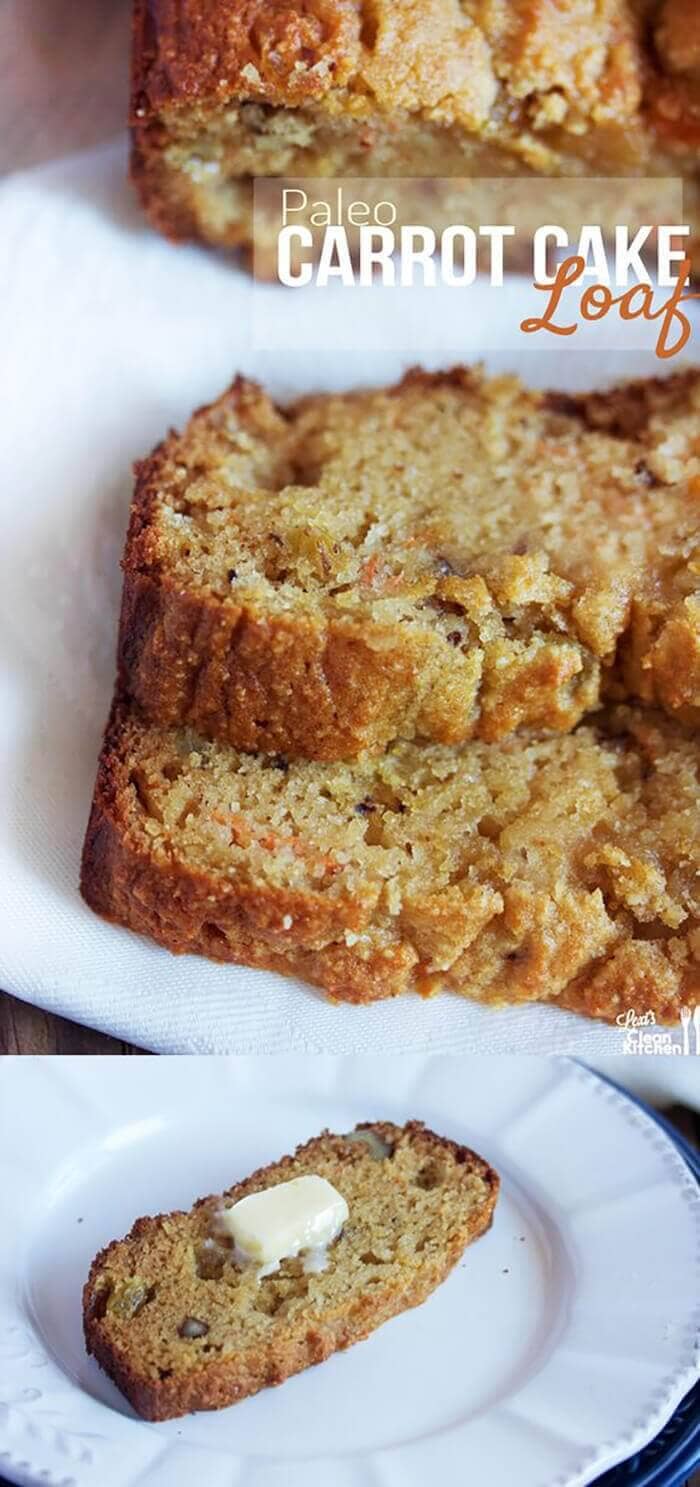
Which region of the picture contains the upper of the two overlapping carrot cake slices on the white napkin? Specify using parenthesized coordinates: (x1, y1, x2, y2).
(119, 367, 700, 760)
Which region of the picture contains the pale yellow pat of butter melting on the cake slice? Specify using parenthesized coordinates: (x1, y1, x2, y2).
(220, 1178, 348, 1273)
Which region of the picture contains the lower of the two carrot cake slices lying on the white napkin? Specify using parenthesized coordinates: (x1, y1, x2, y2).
(82, 703, 700, 1022)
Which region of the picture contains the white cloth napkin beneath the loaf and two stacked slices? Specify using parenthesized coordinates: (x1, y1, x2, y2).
(0, 133, 697, 1056)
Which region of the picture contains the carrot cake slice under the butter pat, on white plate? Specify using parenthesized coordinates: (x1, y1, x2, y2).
(83, 1121, 499, 1420)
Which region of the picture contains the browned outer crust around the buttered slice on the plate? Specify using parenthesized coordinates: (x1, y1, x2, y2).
(83, 1121, 499, 1420)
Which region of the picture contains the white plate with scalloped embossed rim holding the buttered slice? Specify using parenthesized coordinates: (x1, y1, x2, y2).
(0, 1057, 700, 1487)
